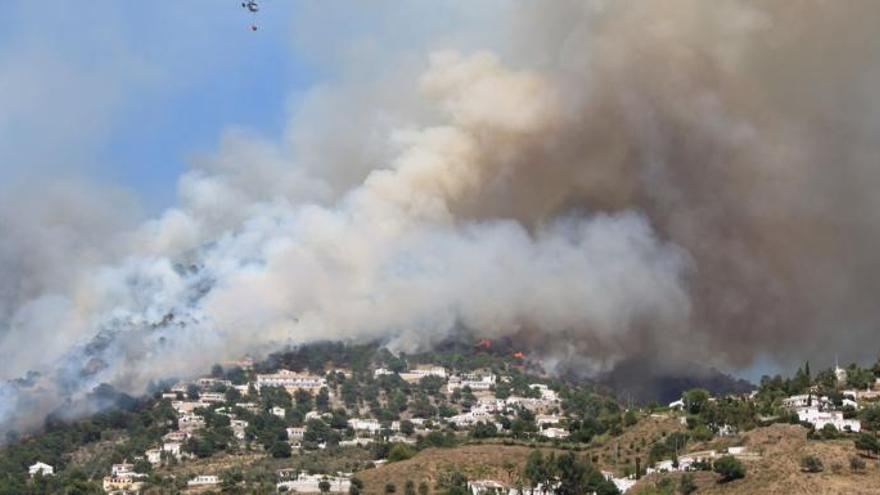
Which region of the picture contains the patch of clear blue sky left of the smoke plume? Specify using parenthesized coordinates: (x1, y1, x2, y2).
(0, 0, 319, 213)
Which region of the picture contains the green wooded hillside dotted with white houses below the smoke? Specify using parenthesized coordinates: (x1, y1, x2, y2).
(0, 343, 880, 495)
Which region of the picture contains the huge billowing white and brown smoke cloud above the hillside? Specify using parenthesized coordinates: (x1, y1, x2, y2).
(0, 0, 880, 434)
